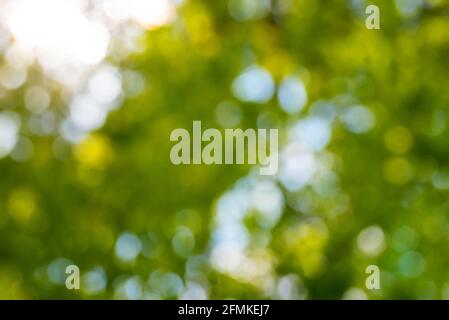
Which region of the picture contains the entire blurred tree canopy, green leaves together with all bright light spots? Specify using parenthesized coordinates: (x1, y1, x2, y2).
(0, 0, 449, 299)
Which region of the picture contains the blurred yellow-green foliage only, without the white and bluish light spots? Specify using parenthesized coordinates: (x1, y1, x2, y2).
(0, 0, 449, 299)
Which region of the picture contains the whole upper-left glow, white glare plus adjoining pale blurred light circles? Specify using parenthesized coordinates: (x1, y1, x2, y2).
(0, 0, 177, 142)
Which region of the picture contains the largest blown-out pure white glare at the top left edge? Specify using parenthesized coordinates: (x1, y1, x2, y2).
(6, 0, 110, 68)
